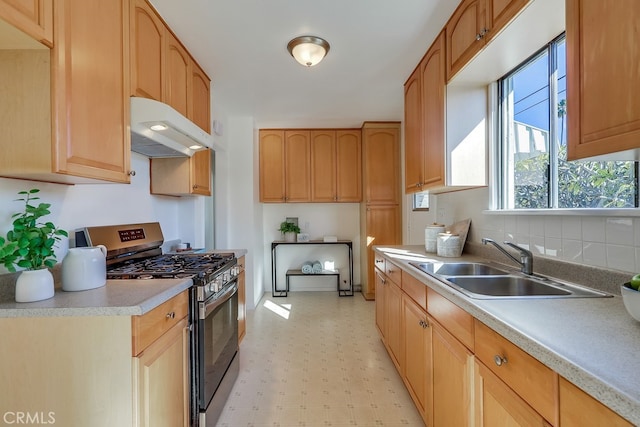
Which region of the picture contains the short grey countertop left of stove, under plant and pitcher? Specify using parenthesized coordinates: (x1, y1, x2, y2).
(0, 278, 193, 318)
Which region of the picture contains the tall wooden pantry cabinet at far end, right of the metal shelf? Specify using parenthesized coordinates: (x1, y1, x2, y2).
(360, 122, 402, 300)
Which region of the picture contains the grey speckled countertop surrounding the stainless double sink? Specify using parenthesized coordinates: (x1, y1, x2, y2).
(374, 246, 640, 425)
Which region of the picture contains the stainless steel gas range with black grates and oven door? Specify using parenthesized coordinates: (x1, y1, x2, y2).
(76, 222, 239, 427)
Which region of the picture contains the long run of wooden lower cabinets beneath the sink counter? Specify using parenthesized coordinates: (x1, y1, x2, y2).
(375, 253, 632, 427)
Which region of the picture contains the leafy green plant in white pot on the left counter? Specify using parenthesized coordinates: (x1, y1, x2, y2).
(0, 188, 68, 302)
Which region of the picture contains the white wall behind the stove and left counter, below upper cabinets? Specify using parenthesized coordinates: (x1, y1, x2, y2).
(0, 153, 205, 271)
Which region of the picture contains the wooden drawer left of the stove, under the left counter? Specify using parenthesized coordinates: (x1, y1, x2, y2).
(131, 290, 189, 356)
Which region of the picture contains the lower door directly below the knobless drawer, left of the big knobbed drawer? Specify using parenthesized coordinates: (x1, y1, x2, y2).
(429, 318, 473, 427)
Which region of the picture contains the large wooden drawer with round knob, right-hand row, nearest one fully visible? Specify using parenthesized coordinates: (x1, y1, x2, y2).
(475, 320, 558, 425)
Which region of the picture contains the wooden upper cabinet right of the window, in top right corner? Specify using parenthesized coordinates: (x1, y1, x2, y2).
(566, 0, 640, 160)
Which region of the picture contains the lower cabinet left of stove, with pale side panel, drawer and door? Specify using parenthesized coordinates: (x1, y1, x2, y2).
(0, 291, 189, 427)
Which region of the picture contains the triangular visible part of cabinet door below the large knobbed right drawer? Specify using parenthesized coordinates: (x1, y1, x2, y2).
(474, 361, 552, 427)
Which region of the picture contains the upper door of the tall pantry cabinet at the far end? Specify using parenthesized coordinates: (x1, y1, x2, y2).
(362, 124, 400, 205)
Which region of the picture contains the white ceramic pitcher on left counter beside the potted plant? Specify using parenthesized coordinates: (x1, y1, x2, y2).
(62, 245, 107, 291)
